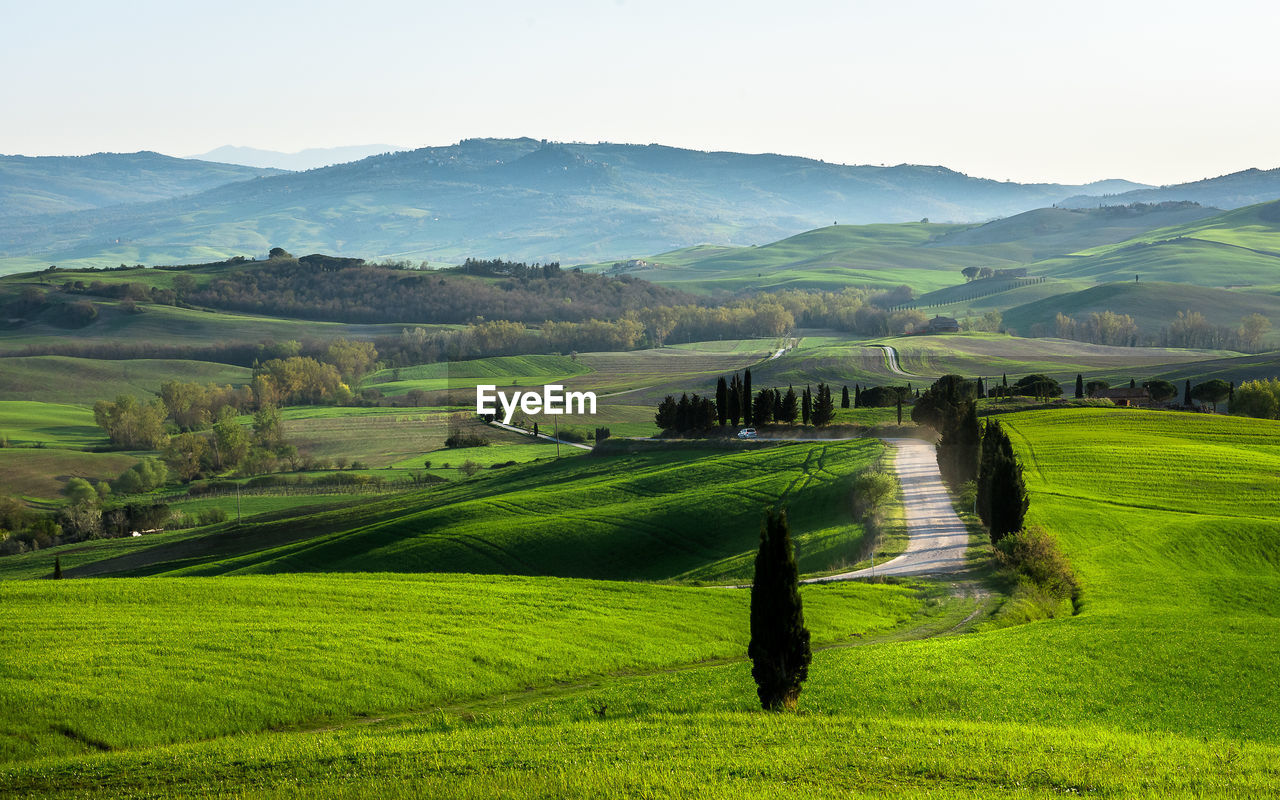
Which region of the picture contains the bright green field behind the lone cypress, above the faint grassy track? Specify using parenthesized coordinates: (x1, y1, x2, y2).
(0, 575, 942, 762)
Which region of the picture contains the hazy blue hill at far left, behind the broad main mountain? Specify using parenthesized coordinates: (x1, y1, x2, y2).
(0, 152, 280, 218)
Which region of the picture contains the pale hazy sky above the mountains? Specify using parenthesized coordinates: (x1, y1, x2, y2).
(0, 0, 1280, 183)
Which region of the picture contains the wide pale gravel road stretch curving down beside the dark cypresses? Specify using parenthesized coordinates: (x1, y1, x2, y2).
(800, 439, 969, 584)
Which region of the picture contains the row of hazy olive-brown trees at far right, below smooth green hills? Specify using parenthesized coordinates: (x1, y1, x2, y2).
(1049, 310, 1271, 352)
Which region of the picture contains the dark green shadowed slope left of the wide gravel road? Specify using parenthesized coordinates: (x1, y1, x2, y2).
(9, 440, 882, 580)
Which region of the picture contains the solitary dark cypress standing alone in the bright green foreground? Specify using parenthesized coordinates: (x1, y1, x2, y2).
(746, 509, 813, 710)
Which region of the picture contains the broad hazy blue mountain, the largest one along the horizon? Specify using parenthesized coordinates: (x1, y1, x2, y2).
(0, 138, 1280, 271)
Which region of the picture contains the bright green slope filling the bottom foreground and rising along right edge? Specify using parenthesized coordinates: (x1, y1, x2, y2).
(0, 410, 1280, 797)
